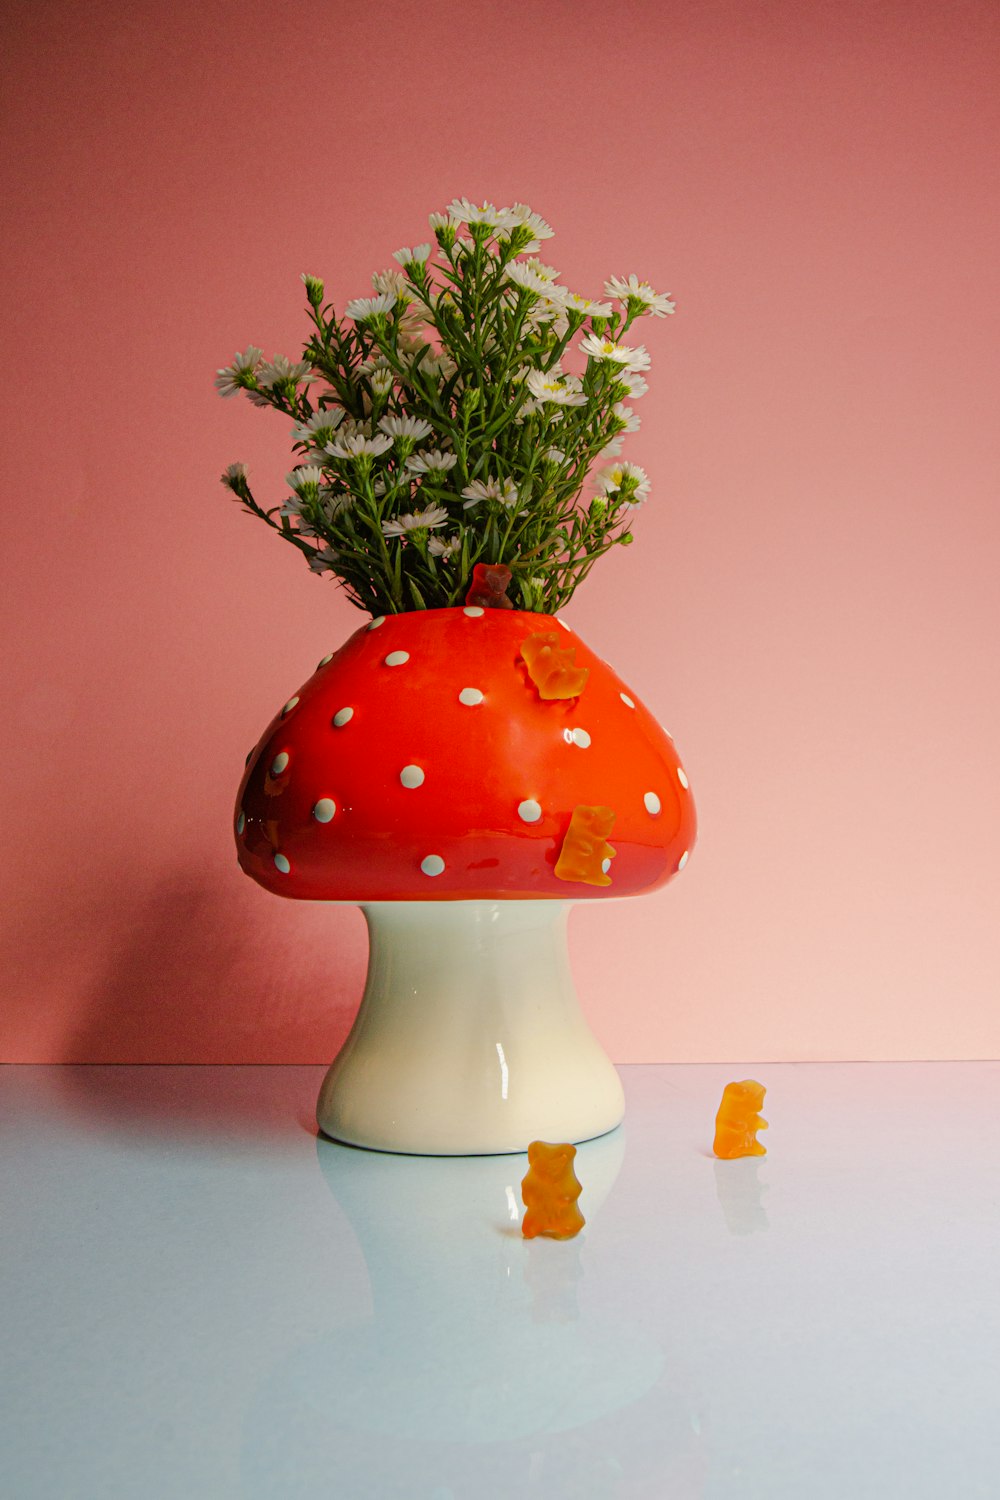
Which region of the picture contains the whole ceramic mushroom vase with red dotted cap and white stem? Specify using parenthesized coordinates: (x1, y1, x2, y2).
(235, 606, 696, 1155)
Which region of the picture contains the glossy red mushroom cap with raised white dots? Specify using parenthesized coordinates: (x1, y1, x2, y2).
(235, 608, 696, 903)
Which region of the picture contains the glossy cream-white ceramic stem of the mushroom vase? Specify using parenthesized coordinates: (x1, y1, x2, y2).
(316, 902, 625, 1157)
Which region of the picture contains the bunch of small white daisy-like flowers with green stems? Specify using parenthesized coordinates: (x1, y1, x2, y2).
(216, 198, 673, 615)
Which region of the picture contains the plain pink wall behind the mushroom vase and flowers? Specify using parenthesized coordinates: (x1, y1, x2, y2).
(0, 0, 1000, 1062)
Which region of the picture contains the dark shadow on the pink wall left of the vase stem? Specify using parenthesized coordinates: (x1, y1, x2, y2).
(61, 872, 364, 1064)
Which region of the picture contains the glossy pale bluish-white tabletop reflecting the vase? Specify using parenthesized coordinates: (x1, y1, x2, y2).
(0, 1064, 1000, 1500)
